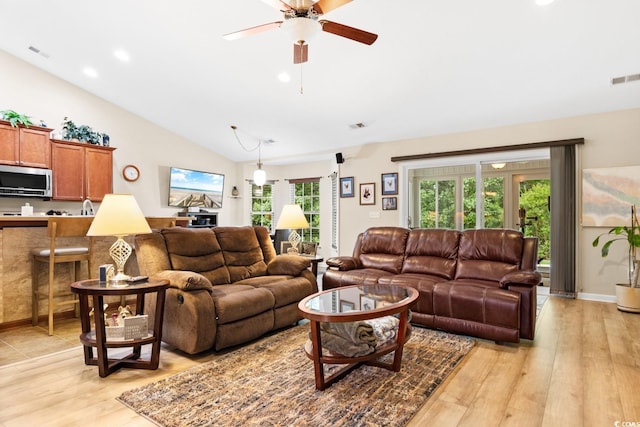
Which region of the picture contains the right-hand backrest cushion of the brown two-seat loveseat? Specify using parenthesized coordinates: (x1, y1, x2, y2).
(215, 227, 267, 283)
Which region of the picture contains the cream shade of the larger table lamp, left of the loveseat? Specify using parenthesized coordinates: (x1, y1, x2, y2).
(87, 194, 151, 236)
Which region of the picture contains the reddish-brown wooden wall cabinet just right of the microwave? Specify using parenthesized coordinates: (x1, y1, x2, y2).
(51, 140, 115, 202)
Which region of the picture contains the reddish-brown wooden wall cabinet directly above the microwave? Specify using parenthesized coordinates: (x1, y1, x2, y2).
(0, 120, 53, 169)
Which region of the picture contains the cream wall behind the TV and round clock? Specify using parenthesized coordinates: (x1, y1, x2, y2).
(0, 51, 237, 225)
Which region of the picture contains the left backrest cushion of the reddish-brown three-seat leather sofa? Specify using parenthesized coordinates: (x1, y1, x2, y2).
(359, 227, 409, 273)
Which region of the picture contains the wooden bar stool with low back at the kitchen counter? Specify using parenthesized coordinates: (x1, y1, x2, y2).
(31, 217, 93, 335)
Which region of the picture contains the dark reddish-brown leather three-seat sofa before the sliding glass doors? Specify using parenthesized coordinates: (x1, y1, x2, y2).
(322, 227, 541, 342)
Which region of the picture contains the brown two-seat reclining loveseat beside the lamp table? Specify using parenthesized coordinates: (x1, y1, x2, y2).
(135, 227, 318, 354)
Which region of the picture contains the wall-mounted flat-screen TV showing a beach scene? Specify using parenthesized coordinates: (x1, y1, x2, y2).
(169, 167, 224, 209)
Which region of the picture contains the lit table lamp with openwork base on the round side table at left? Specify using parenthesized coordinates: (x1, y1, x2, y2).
(87, 194, 151, 282)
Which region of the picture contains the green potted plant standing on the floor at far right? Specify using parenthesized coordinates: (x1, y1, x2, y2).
(593, 205, 640, 313)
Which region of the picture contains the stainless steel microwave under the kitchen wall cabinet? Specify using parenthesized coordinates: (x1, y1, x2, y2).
(0, 165, 52, 200)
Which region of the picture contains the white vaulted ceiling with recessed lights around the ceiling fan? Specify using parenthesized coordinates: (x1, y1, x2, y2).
(0, 0, 640, 164)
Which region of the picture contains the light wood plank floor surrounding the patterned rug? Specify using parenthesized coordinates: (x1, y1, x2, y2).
(0, 298, 640, 427)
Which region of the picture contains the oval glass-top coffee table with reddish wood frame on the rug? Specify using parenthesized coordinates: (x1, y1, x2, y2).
(298, 285, 418, 390)
